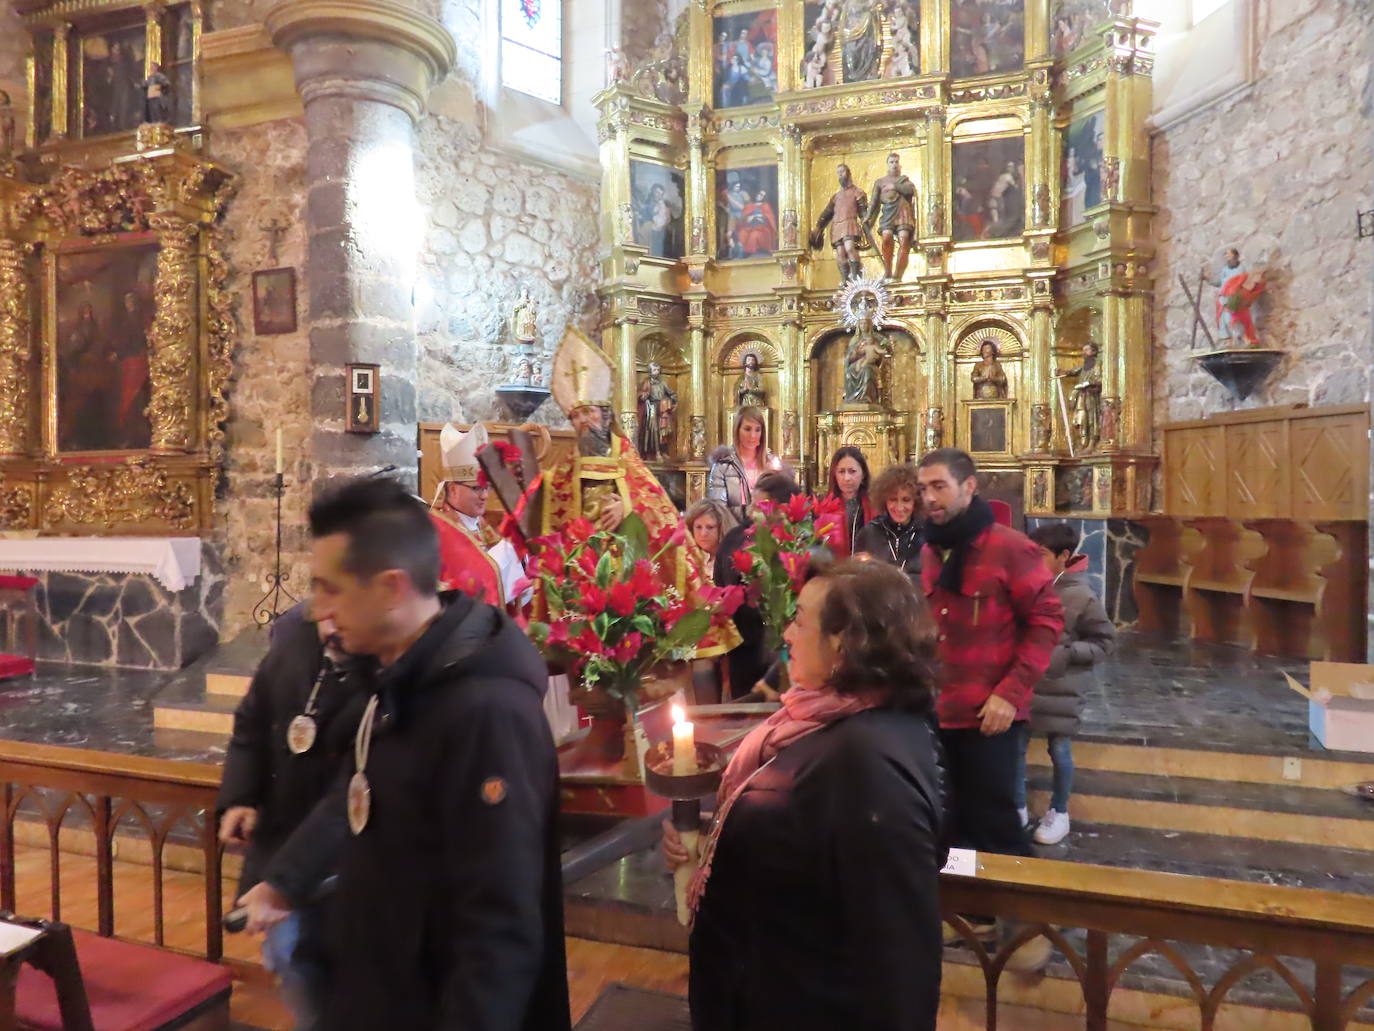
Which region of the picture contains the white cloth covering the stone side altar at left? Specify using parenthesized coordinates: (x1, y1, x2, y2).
(0, 537, 201, 591)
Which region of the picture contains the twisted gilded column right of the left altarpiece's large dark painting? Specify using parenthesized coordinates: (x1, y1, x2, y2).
(148, 214, 198, 454)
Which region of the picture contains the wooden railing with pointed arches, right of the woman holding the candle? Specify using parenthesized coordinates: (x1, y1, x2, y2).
(941, 855, 1374, 1031)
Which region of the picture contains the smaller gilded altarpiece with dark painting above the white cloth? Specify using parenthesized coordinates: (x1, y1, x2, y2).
(0, 0, 234, 535)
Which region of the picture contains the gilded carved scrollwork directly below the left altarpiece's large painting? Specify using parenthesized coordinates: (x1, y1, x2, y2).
(43, 458, 195, 531)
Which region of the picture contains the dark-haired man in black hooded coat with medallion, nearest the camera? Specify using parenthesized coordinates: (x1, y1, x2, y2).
(268, 478, 572, 1031)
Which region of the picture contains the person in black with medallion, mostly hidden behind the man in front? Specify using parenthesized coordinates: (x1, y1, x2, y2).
(216, 602, 365, 1031)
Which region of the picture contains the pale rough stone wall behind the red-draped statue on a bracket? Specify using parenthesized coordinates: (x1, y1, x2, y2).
(1153, 0, 1374, 422)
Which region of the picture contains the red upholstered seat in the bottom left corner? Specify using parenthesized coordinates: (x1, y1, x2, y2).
(15, 931, 232, 1031)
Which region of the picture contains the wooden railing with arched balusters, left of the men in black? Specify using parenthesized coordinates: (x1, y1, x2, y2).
(0, 741, 224, 962)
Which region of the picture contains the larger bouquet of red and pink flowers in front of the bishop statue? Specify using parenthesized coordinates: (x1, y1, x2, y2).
(529, 513, 743, 712)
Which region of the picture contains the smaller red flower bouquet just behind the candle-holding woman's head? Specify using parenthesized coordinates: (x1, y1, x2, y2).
(734, 494, 844, 654)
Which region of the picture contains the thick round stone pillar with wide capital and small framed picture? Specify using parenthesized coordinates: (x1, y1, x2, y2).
(264, 0, 456, 483)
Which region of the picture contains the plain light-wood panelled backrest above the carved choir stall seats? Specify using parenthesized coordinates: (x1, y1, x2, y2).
(1161, 404, 1370, 522)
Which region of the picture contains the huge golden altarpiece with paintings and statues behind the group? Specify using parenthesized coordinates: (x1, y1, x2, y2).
(596, 0, 1156, 517)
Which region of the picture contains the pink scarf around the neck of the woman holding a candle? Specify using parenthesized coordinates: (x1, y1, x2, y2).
(687, 686, 878, 916)
